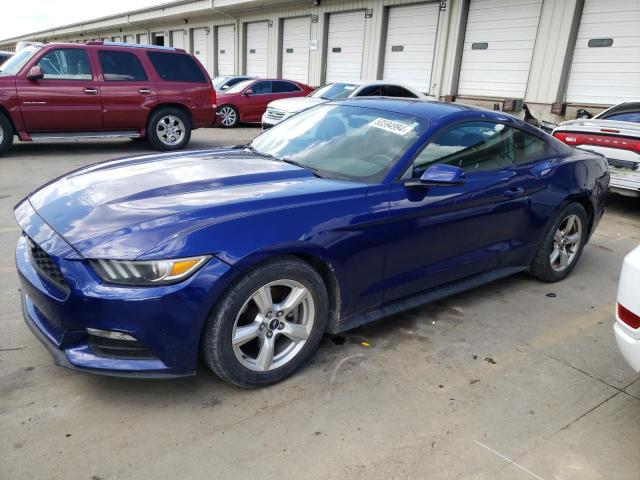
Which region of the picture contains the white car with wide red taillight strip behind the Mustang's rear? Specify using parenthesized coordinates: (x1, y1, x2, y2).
(553, 102, 640, 197)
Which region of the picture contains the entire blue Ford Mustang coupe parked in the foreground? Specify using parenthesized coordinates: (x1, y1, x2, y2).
(15, 99, 609, 387)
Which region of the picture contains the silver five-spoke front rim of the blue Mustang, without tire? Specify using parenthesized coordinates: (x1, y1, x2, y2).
(231, 279, 315, 372)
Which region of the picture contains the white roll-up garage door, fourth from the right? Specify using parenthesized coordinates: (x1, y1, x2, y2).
(326, 10, 365, 82)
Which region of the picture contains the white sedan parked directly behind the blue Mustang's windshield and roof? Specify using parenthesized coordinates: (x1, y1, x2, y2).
(262, 80, 430, 130)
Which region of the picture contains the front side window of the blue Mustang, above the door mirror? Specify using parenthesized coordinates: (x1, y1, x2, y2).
(405, 122, 515, 178)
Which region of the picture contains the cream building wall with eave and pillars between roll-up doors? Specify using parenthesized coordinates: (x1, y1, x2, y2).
(0, 0, 632, 122)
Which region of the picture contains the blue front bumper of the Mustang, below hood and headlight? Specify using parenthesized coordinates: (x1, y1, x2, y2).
(16, 204, 230, 378)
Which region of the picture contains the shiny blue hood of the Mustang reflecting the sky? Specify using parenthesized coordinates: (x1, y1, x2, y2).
(18, 148, 362, 260)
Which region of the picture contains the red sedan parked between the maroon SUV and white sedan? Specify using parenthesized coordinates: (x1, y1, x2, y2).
(218, 78, 313, 128)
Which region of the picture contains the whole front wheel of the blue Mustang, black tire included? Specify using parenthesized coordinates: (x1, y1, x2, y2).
(202, 256, 329, 388)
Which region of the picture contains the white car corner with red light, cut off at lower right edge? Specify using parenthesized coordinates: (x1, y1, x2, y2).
(613, 246, 640, 373)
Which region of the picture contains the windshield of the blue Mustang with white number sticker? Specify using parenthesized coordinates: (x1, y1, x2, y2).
(250, 104, 428, 182)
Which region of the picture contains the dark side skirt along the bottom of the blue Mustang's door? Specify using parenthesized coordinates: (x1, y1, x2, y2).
(328, 267, 527, 334)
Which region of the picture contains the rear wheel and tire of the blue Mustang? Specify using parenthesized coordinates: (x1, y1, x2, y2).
(529, 203, 589, 282)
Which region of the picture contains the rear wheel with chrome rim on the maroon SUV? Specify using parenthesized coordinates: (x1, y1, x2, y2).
(147, 108, 191, 151)
